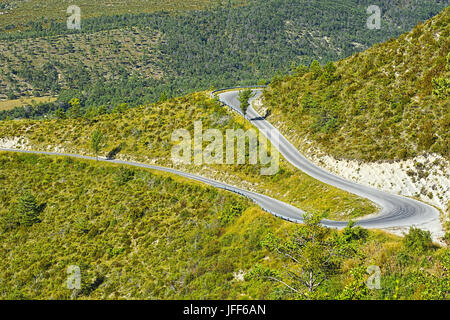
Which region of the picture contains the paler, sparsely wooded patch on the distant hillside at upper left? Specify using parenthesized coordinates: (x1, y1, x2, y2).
(0, 28, 166, 92)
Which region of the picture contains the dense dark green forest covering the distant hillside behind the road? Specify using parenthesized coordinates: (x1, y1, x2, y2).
(0, 0, 447, 119)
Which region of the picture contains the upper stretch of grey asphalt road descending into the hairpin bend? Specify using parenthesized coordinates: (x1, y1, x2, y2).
(218, 89, 439, 228)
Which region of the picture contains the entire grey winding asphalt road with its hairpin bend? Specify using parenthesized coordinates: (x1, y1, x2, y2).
(0, 90, 439, 228)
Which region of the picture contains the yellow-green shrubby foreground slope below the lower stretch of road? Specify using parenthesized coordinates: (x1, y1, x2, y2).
(0, 153, 449, 299)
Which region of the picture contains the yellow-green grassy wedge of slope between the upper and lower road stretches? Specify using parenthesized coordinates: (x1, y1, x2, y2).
(0, 92, 376, 220)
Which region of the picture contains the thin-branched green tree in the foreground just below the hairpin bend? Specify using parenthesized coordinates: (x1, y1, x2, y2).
(262, 215, 343, 298)
